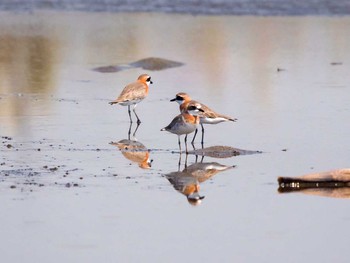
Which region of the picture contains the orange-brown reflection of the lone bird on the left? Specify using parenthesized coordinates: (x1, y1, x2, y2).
(110, 139, 152, 169)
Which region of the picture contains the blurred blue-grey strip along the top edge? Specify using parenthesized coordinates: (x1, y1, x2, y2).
(0, 0, 350, 16)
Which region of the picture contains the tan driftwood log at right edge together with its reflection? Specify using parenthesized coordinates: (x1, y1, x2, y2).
(278, 169, 350, 198)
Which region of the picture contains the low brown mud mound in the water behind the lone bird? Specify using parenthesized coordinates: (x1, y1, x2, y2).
(93, 57, 184, 73)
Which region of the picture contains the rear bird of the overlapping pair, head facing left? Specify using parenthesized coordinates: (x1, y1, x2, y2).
(170, 92, 237, 146)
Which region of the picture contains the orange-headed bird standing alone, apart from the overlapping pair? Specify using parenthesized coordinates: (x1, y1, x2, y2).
(109, 74, 153, 124)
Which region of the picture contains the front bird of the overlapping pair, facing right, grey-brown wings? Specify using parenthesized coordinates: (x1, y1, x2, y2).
(161, 103, 203, 153)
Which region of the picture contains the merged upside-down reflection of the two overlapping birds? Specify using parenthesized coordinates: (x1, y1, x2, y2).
(165, 162, 234, 205)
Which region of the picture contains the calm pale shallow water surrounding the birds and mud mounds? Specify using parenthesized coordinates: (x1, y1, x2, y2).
(0, 12, 350, 262)
